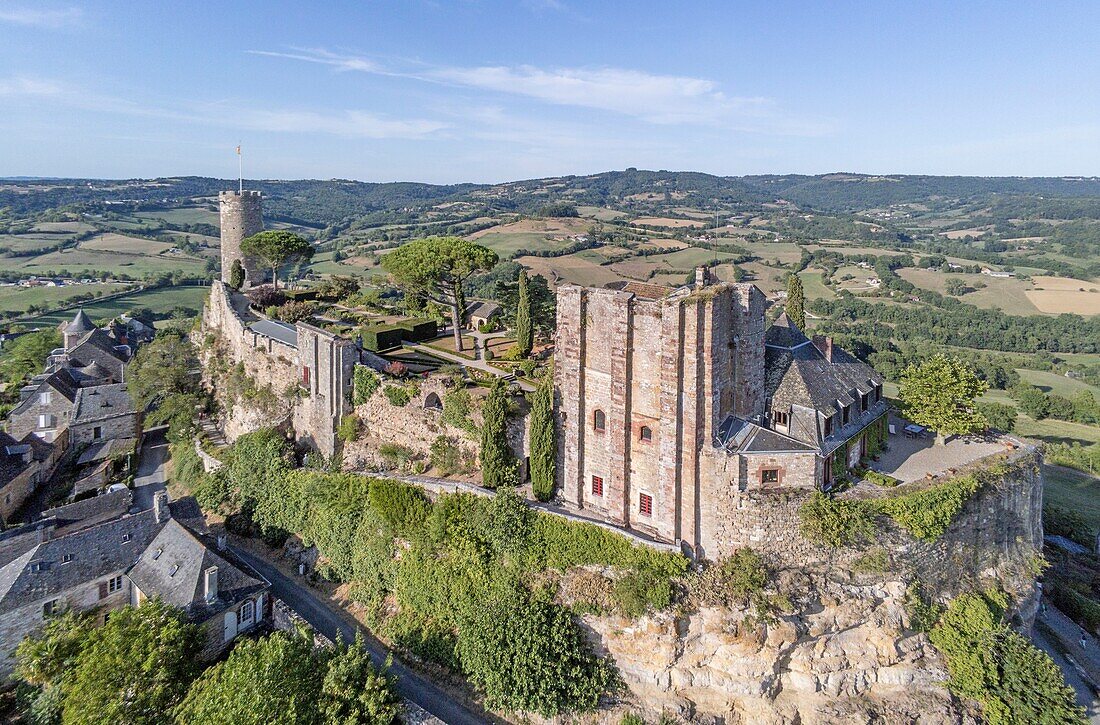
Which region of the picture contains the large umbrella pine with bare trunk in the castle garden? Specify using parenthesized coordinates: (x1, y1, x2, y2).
(382, 237, 498, 352)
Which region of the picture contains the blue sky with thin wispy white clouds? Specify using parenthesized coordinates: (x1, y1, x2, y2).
(0, 0, 1100, 183)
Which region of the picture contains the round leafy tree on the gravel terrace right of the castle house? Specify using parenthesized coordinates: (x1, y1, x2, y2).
(899, 353, 989, 443)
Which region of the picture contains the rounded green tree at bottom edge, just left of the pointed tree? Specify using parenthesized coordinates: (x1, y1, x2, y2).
(173, 631, 326, 725)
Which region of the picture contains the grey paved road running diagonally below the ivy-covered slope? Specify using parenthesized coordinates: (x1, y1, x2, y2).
(233, 548, 496, 725)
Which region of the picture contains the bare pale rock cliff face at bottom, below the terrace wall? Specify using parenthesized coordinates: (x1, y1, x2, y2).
(585, 581, 966, 723)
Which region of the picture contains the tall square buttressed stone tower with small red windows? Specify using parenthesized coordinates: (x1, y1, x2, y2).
(554, 278, 765, 556)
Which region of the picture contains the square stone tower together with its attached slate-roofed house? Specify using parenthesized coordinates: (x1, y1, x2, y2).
(554, 270, 887, 558)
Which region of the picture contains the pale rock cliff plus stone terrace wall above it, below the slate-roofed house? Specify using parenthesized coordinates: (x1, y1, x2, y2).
(584, 449, 1042, 723)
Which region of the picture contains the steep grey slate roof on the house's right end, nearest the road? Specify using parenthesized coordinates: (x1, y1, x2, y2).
(128, 519, 266, 618)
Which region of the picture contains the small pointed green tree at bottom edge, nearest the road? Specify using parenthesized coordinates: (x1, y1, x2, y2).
(318, 631, 400, 725)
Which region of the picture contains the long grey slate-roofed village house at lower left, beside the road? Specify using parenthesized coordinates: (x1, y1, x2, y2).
(0, 491, 271, 674)
